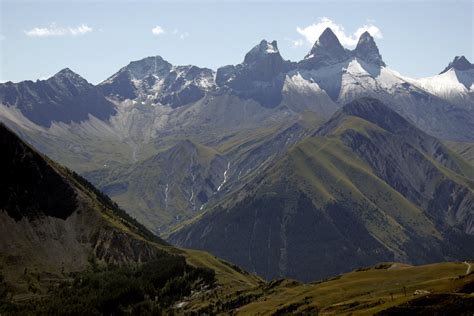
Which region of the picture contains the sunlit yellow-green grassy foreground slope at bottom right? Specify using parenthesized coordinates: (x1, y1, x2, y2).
(169, 262, 474, 315)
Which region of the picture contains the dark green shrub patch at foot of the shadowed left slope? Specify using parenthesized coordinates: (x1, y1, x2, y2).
(0, 255, 215, 315)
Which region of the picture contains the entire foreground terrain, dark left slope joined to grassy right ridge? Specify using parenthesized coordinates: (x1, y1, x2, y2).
(0, 124, 474, 315)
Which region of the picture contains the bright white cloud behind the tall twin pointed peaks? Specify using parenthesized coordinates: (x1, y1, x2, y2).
(294, 17, 383, 46)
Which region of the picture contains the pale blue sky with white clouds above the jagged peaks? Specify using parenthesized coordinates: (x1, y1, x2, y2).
(0, 0, 474, 83)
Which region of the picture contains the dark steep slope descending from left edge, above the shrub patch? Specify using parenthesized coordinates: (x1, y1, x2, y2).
(0, 124, 260, 304)
